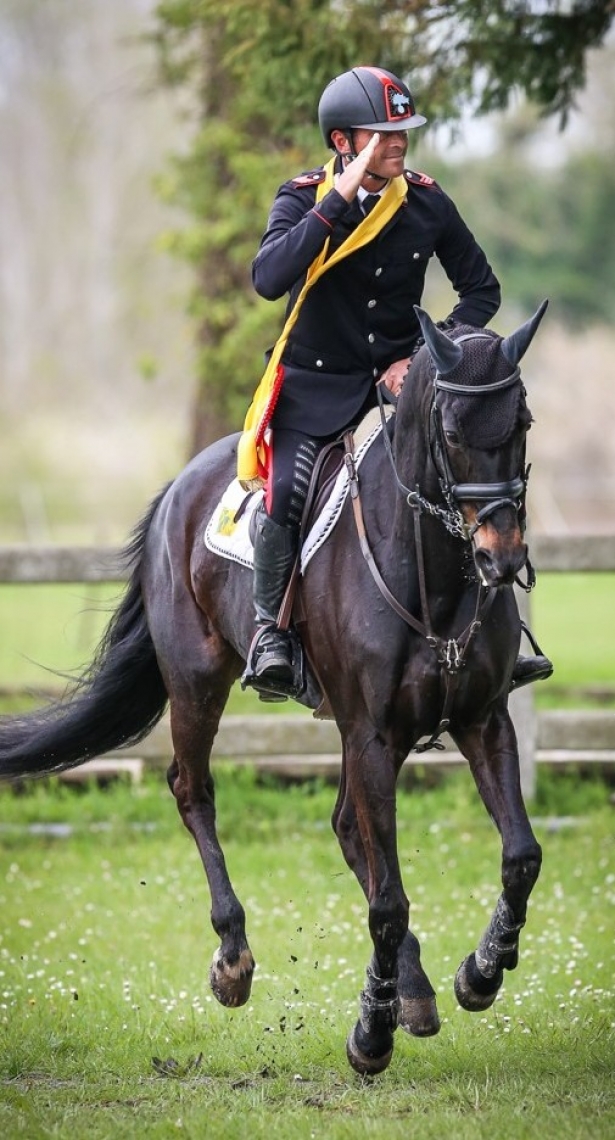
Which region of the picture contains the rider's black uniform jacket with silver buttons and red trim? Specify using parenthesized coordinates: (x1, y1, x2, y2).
(252, 169, 500, 435)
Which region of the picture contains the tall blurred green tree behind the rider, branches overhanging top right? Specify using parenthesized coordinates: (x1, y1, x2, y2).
(153, 0, 615, 450)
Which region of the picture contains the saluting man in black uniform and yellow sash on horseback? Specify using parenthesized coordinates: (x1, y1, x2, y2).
(237, 67, 554, 693)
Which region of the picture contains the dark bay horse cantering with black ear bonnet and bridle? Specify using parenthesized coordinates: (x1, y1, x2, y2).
(0, 306, 544, 1074)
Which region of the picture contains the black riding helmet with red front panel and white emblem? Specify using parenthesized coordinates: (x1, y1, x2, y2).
(318, 67, 427, 147)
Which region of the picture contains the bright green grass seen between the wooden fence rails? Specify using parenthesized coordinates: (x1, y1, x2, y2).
(0, 573, 615, 711)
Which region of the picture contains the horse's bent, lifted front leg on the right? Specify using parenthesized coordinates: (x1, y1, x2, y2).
(454, 709, 542, 1010)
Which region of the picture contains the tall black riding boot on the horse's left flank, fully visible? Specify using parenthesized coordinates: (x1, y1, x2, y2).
(252, 511, 299, 689)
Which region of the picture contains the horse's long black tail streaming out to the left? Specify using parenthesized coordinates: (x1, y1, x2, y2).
(0, 491, 168, 780)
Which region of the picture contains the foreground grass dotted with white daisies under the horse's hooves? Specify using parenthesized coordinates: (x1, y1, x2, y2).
(0, 770, 615, 1140)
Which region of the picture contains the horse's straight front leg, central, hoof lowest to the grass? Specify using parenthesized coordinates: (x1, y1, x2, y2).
(333, 735, 408, 1074)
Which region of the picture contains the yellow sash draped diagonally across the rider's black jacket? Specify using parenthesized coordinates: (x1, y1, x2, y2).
(237, 158, 407, 491)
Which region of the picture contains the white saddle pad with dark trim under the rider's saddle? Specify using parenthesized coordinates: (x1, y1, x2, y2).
(204, 407, 393, 573)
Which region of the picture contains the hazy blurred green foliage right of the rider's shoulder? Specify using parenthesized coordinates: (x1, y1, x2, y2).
(428, 148, 615, 329)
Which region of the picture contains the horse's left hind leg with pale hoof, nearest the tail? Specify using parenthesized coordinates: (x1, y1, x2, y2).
(162, 635, 254, 1007)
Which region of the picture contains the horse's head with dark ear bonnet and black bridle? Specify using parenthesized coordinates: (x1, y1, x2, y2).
(416, 301, 547, 586)
